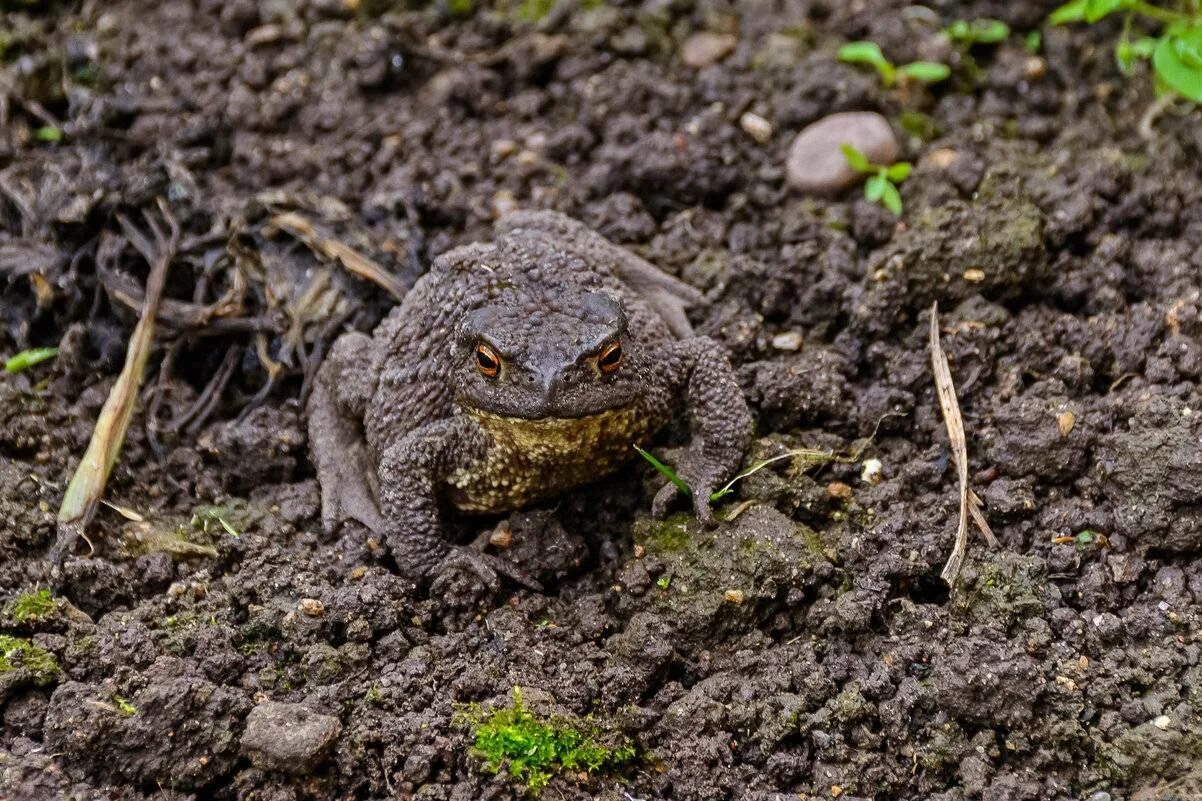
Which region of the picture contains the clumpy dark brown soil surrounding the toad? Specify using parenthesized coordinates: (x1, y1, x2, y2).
(0, 0, 1202, 801)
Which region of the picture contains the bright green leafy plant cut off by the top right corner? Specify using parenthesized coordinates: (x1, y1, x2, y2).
(1048, 0, 1202, 103)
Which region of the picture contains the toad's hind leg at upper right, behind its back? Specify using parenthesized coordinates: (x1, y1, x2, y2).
(496, 206, 702, 339)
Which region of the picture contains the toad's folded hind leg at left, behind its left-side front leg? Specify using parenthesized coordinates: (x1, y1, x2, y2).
(308, 333, 383, 532)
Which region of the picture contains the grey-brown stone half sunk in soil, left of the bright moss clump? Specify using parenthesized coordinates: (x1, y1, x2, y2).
(242, 701, 343, 773)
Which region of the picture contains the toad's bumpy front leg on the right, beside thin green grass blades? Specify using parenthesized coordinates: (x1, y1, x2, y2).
(651, 337, 751, 526)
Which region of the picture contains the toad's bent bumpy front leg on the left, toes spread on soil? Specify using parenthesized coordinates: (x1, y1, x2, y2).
(379, 416, 541, 592)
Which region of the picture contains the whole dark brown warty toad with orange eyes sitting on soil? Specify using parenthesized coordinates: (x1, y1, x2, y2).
(309, 212, 751, 586)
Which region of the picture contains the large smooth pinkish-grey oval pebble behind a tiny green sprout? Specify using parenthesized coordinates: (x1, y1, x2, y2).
(785, 112, 900, 195)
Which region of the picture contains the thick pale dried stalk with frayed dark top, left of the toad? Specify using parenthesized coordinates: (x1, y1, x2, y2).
(50, 198, 179, 562)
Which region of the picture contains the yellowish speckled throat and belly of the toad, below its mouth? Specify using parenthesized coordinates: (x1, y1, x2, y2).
(447, 409, 660, 512)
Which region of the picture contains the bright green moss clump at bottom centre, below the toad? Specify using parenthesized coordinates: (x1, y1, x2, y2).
(462, 687, 635, 795)
